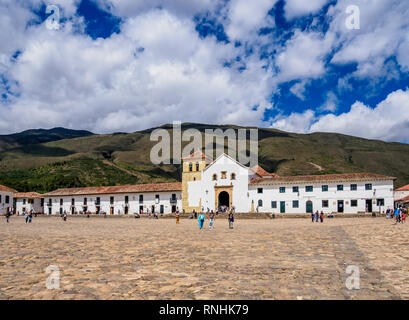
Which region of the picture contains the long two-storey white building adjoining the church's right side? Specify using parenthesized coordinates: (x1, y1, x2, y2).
(249, 173, 394, 213)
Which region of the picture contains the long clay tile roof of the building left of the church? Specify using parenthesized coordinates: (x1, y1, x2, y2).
(43, 182, 182, 197)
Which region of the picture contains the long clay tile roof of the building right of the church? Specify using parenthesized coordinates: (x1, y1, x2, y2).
(250, 173, 396, 184)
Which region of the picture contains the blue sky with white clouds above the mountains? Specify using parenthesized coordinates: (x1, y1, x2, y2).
(0, 0, 409, 142)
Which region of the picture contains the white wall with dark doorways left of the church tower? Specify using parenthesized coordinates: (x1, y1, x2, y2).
(44, 191, 182, 215)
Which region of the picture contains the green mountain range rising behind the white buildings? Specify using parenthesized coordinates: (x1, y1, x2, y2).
(0, 123, 409, 192)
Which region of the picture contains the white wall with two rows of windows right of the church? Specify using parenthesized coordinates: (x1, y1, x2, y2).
(249, 180, 393, 213)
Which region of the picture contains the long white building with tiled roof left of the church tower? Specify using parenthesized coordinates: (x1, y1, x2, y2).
(43, 182, 182, 215)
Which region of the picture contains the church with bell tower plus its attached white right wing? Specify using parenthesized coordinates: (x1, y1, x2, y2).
(182, 152, 395, 214)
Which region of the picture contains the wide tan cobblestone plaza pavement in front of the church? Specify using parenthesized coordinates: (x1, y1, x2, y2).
(0, 217, 409, 299)
